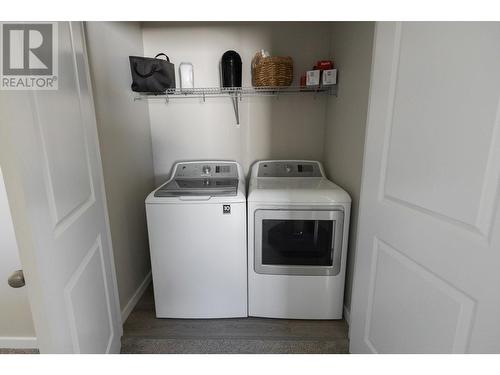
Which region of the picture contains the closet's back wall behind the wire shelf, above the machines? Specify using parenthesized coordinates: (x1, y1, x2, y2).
(142, 22, 330, 184)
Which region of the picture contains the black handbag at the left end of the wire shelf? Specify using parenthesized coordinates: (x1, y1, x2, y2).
(129, 53, 175, 93)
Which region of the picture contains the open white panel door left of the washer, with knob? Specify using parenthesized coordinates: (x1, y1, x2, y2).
(1, 22, 122, 353)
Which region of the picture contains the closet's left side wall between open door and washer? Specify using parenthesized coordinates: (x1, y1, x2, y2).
(86, 22, 154, 318)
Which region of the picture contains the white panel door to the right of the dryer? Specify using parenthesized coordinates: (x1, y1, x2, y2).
(350, 22, 500, 353)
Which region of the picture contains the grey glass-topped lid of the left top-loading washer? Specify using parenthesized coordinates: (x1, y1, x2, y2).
(154, 178, 238, 197)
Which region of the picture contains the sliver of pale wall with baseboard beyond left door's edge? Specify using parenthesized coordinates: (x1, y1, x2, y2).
(0, 168, 37, 348)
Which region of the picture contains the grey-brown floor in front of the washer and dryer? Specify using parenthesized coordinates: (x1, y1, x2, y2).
(122, 286, 348, 354)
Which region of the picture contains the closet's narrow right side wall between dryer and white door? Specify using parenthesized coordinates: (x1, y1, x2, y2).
(324, 22, 374, 310)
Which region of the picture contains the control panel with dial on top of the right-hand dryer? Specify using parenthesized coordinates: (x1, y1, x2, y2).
(257, 160, 323, 177)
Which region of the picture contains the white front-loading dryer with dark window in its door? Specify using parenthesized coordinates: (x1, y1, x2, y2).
(247, 160, 351, 319)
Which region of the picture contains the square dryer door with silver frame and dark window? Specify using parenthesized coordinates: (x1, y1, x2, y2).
(254, 209, 344, 276)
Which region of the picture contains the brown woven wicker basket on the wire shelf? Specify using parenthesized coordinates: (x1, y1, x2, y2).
(252, 53, 293, 87)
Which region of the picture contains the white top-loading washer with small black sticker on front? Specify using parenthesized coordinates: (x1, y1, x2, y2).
(146, 161, 247, 318)
